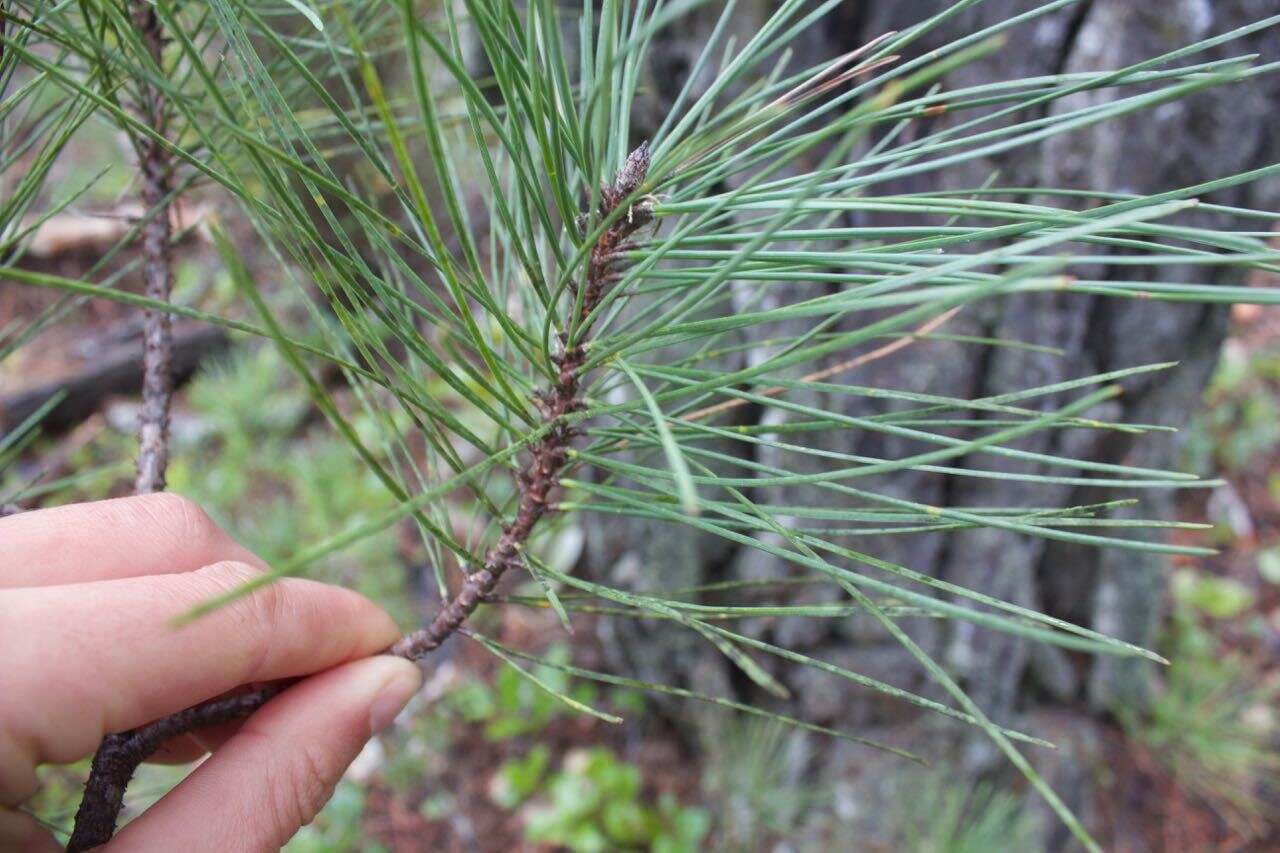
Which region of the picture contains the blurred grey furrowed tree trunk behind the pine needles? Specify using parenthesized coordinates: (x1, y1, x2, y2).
(585, 0, 1280, 847)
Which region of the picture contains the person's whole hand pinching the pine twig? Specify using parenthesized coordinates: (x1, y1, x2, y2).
(0, 493, 422, 853)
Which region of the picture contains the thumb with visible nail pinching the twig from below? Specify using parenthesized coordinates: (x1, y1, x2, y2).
(110, 656, 422, 850)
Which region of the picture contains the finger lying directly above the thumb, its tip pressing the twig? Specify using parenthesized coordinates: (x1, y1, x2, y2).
(0, 562, 399, 803)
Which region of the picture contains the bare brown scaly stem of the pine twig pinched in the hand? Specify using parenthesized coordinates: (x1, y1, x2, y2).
(67, 143, 653, 852)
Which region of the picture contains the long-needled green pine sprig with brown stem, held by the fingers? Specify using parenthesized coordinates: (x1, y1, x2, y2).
(0, 0, 1280, 848)
